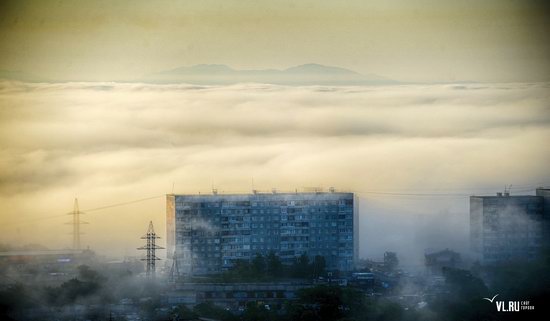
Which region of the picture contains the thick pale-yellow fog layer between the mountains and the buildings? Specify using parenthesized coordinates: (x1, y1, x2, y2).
(0, 82, 550, 256)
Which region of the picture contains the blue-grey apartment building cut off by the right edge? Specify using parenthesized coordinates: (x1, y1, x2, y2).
(470, 188, 550, 264)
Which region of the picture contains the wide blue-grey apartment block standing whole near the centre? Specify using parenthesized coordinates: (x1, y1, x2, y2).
(166, 192, 358, 275)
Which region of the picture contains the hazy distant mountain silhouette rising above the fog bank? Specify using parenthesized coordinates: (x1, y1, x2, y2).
(141, 64, 398, 85)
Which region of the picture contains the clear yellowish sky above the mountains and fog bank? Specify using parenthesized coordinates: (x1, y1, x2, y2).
(0, 0, 550, 82)
